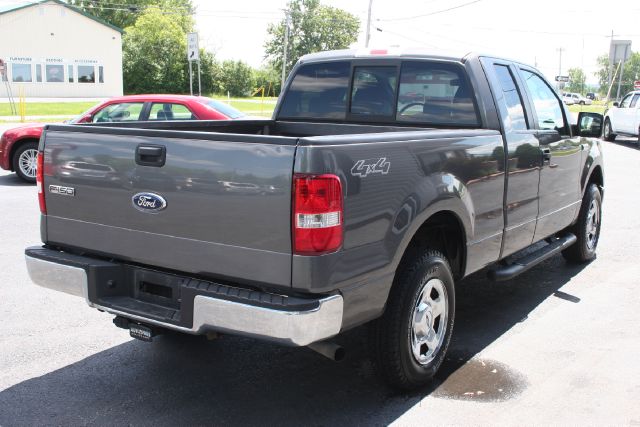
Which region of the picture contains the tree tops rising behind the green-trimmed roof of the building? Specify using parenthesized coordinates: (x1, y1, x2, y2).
(68, 0, 193, 31)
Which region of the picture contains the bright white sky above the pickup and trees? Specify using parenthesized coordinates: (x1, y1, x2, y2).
(193, 0, 640, 84)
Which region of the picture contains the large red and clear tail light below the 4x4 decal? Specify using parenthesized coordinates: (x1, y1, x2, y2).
(293, 174, 343, 255)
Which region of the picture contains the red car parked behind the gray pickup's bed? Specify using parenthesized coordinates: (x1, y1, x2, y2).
(0, 95, 246, 183)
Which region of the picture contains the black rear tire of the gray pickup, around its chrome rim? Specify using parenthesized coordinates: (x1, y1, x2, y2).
(370, 250, 455, 390)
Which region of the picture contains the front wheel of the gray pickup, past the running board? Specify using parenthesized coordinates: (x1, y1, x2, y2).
(562, 184, 602, 264)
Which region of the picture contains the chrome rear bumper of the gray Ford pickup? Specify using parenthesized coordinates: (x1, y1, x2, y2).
(26, 249, 343, 346)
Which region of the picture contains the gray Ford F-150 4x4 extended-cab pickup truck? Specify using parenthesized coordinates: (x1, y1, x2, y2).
(26, 50, 604, 389)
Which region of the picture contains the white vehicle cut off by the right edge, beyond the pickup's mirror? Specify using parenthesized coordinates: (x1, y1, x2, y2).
(602, 90, 640, 144)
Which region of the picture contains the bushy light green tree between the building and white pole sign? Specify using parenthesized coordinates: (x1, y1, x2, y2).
(122, 6, 189, 93)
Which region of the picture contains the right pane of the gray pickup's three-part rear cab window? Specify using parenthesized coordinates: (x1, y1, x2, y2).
(396, 61, 479, 126)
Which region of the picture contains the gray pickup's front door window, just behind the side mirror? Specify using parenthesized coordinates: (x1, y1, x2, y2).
(522, 70, 569, 135)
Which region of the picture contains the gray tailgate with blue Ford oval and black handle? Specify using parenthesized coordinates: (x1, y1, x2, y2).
(41, 126, 296, 286)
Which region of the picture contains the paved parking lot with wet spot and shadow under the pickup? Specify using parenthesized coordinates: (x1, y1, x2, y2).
(0, 135, 640, 426)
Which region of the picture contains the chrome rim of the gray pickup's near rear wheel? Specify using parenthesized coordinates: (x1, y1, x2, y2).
(410, 279, 449, 365)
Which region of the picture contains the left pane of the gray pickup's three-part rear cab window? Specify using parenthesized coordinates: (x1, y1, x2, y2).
(279, 62, 351, 120)
